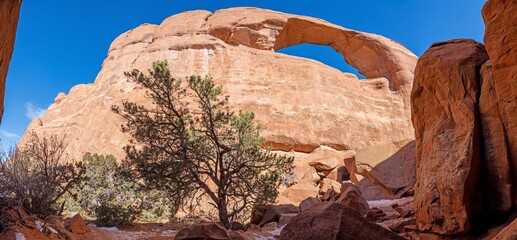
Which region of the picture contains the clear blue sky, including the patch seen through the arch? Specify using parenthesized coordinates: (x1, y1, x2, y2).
(0, 0, 485, 144)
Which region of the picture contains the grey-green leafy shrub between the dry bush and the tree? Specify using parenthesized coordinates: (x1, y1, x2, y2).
(68, 153, 168, 226)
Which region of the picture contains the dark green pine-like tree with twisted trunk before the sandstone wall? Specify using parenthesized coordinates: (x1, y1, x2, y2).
(112, 62, 293, 228)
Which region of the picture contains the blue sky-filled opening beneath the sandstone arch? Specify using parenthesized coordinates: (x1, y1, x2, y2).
(277, 43, 366, 80)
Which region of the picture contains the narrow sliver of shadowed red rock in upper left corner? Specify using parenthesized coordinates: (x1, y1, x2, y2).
(0, 0, 22, 122)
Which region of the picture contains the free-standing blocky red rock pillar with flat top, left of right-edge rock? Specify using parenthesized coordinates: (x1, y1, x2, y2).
(411, 39, 488, 234)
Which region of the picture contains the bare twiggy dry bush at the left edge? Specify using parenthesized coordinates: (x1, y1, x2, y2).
(0, 133, 84, 232)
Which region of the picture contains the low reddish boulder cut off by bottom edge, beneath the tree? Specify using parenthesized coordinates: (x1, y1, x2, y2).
(174, 223, 231, 240)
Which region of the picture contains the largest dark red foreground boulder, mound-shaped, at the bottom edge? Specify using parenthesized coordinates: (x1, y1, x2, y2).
(280, 202, 404, 240)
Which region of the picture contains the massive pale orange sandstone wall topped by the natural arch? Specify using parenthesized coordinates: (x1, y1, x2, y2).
(21, 8, 417, 168)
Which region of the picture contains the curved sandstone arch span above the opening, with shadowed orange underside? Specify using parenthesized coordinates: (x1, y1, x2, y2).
(207, 8, 417, 91)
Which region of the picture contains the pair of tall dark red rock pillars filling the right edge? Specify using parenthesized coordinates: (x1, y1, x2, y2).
(411, 0, 517, 234)
